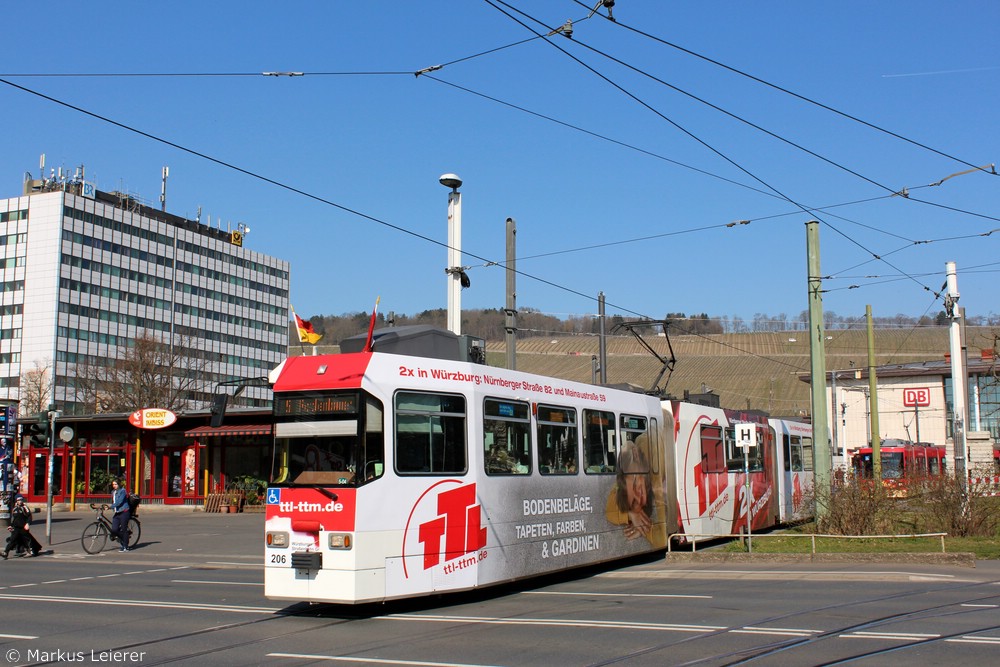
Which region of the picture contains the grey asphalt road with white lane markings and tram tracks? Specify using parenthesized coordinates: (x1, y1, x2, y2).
(0, 510, 1000, 667)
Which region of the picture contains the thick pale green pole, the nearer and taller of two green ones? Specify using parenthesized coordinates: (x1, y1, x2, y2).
(806, 220, 833, 519)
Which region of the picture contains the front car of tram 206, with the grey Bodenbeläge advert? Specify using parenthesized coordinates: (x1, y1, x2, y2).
(264, 353, 677, 603)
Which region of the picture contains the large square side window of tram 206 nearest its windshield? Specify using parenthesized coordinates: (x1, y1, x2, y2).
(395, 391, 468, 475)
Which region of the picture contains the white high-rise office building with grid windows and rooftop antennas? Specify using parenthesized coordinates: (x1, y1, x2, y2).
(0, 172, 289, 415)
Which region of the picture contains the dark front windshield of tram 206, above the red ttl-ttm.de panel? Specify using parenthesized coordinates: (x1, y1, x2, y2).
(272, 391, 384, 486)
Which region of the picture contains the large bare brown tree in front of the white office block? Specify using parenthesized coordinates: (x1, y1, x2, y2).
(76, 331, 214, 412)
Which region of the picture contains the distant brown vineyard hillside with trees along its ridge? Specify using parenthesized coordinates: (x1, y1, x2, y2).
(290, 310, 1000, 416)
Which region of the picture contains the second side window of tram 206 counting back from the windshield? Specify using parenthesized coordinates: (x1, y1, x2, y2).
(483, 398, 531, 475)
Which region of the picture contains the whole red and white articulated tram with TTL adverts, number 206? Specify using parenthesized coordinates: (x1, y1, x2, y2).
(264, 332, 812, 603)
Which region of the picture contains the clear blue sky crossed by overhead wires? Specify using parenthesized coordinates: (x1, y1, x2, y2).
(0, 0, 1000, 328)
